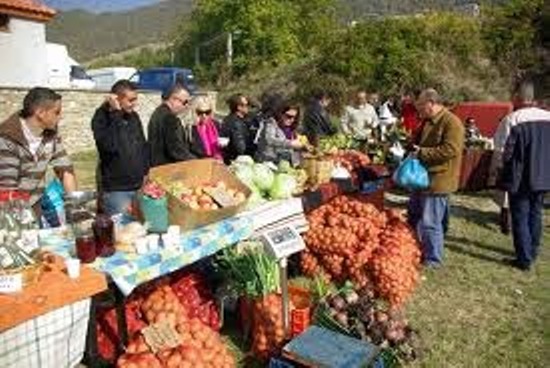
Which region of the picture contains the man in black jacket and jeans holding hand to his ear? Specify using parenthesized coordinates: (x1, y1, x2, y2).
(92, 80, 149, 215)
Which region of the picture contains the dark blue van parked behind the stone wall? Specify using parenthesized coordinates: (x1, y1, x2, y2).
(130, 67, 197, 94)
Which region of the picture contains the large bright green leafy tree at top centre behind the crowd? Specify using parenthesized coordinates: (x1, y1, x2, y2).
(177, 0, 336, 81)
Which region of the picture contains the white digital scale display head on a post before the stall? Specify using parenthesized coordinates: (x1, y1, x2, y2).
(261, 225, 306, 259)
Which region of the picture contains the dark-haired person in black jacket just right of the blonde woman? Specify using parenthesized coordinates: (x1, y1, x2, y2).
(221, 94, 253, 162)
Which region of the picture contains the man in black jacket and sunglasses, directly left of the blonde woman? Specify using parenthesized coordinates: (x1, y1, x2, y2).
(147, 84, 196, 166)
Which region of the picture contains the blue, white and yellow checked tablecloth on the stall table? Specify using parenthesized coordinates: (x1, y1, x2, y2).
(40, 216, 253, 295)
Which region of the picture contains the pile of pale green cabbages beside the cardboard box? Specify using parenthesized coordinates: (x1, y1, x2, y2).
(230, 156, 307, 203)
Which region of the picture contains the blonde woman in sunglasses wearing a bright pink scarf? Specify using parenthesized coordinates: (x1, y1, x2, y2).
(190, 97, 225, 160)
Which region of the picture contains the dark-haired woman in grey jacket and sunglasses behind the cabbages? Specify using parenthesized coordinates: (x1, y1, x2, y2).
(256, 103, 304, 166)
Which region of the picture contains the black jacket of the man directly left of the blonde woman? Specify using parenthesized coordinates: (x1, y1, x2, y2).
(147, 104, 197, 166)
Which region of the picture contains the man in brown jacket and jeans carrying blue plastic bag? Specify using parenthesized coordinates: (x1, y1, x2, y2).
(408, 89, 464, 267)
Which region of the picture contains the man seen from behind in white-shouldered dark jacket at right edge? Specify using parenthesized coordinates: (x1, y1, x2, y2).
(492, 82, 550, 270)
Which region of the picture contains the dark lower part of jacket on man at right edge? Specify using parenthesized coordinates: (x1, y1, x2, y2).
(499, 121, 550, 193)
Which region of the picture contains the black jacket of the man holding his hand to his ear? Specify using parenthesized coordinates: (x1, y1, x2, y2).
(92, 104, 149, 192)
